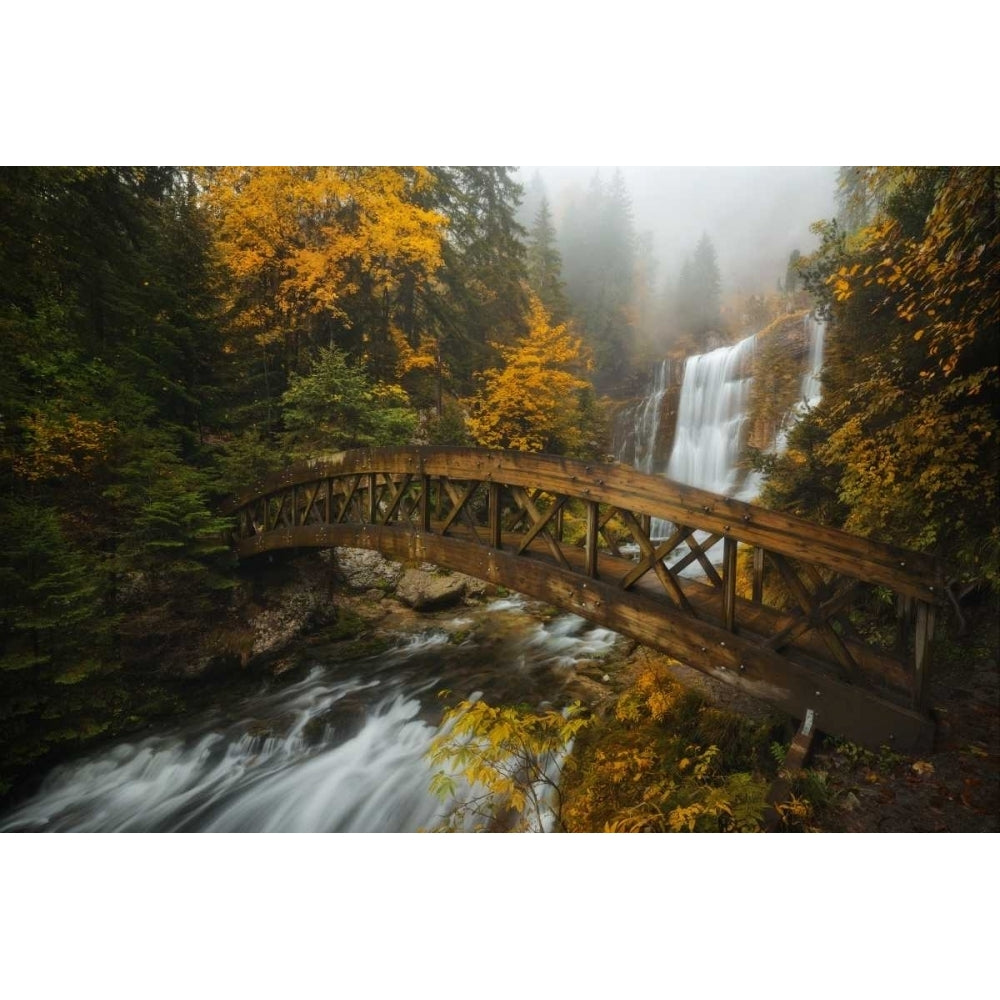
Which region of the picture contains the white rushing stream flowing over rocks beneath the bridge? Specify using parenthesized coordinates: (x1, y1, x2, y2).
(0, 598, 617, 832)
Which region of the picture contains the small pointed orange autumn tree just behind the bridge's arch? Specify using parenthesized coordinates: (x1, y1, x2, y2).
(468, 295, 593, 455)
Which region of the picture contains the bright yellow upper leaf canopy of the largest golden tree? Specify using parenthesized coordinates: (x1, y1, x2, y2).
(203, 167, 445, 344)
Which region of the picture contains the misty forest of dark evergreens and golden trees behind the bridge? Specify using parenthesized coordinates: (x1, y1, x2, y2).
(0, 167, 1000, 824)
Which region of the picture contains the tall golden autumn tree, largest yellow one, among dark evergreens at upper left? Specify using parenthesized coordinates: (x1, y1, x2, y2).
(201, 167, 445, 424)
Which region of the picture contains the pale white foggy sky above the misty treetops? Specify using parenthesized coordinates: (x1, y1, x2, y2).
(517, 166, 838, 294)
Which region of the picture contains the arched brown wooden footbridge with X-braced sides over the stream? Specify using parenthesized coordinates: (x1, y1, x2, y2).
(227, 447, 945, 751)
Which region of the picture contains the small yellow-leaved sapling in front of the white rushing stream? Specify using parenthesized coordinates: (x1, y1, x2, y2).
(428, 701, 589, 832)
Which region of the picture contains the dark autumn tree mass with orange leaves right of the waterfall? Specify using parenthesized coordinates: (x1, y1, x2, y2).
(765, 167, 1000, 586)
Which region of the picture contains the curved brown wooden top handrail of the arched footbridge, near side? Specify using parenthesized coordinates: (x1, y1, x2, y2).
(224, 446, 946, 604)
